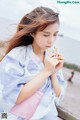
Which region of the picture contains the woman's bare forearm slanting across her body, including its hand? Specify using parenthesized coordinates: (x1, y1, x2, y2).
(16, 54, 58, 104)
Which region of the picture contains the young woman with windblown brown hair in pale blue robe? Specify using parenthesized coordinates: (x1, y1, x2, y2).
(0, 7, 66, 120)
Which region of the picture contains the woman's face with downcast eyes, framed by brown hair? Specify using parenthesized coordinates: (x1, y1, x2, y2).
(33, 22, 59, 50)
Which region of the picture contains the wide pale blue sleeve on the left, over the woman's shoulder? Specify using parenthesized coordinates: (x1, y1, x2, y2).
(0, 46, 27, 107)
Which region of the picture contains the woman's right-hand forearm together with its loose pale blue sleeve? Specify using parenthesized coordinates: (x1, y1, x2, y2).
(51, 69, 67, 106)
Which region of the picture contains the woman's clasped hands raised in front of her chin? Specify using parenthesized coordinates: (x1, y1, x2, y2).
(44, 53, 64, 75)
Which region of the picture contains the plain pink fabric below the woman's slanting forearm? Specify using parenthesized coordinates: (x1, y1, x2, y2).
(10, 91, 43, 120)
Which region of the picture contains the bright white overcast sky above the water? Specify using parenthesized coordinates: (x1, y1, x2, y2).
(0, 0, 80, 40)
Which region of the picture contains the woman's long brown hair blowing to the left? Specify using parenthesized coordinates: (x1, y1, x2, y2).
(5, 7, 59, 55)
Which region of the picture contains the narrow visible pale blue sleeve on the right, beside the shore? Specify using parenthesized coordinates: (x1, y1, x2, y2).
(55, 70, 67, 106)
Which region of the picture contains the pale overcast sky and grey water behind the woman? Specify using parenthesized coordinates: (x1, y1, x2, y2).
(0, 0, 80, 66)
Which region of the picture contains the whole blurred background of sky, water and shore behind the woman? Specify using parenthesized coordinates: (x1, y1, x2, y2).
(0, 0, 80, 119)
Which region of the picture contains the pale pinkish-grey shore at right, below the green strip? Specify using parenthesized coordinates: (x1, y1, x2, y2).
(61, 68, 80, 116)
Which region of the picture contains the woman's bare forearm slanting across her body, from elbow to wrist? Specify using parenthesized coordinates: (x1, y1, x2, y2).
(16, 70, 49, 104)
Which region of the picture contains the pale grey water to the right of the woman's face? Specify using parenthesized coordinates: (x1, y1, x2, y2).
(55, 37, 80, 66)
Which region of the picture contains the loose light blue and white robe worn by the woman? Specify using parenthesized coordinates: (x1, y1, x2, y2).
(0, 45, 66, 120)
